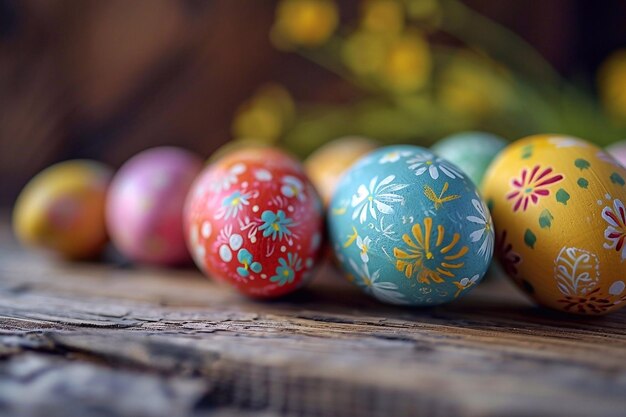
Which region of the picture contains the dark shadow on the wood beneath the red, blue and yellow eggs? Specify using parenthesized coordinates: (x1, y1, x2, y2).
(249, 264, 626, 334)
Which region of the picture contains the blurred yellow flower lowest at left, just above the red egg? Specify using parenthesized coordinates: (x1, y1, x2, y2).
(232, 84, 295, 143)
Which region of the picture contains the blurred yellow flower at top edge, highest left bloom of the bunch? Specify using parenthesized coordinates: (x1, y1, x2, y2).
(271, 0, 339, 48)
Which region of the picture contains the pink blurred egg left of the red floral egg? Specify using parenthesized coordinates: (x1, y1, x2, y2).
(106, 147, 202, 265)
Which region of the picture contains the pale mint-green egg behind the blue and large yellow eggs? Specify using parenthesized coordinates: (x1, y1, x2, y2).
(431, 132, 508, 188)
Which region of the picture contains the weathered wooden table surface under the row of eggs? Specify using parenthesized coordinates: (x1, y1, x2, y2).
(0, 225, 626, 417)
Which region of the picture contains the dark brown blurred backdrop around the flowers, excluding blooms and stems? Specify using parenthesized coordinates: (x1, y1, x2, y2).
(0, 0, 626, 206)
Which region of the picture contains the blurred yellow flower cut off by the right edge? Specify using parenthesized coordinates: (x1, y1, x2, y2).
(598, 49, 626, 121)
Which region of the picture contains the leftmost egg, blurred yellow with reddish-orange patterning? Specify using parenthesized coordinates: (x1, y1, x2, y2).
(13, 160, 113, 259)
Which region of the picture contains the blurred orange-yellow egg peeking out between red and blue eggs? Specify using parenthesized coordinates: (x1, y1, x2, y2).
(304, 136, 378, 207)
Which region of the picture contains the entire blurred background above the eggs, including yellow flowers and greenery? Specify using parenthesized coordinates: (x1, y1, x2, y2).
(0, 0, 626, 206)
